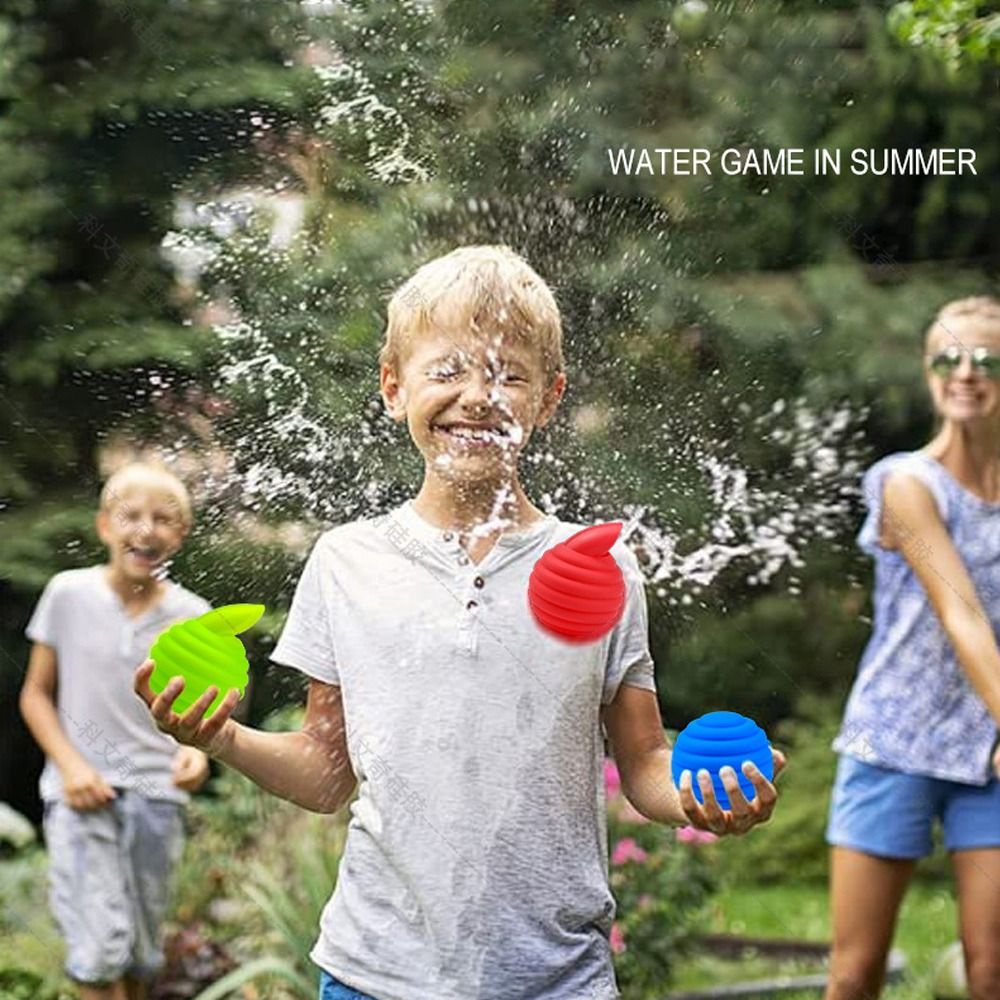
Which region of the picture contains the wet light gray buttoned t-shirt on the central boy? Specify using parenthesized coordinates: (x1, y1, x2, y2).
(272, 501, 655, 1000)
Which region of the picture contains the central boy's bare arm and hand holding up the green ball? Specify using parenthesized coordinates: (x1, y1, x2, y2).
(135, 660, 357, 813)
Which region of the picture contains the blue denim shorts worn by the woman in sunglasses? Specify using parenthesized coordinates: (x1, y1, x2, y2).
(826, 754, 1000, 859)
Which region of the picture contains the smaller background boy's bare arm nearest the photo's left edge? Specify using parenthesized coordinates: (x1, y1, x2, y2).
(18, 642, 116, 809)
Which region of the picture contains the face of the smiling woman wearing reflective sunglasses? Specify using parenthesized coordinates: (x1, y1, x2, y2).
(924, 318, 1000, 423)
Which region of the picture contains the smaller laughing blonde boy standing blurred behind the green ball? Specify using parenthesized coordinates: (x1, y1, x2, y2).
(20, 463, 210, 1000)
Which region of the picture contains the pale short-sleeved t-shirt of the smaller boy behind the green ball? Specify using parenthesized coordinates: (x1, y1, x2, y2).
(25, 566, 211, 802)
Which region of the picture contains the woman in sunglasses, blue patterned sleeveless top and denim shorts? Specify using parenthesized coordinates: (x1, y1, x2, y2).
(824, 296, 1000, 1000)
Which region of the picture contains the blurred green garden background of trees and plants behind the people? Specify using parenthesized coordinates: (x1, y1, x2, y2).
(0, 0, 1000, 1000)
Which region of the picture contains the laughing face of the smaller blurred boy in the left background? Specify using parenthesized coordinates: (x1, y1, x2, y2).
(97, 487, 188, 584)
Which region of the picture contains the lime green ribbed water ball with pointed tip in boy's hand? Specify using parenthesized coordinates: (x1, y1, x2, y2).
(149, 604, 264, 719)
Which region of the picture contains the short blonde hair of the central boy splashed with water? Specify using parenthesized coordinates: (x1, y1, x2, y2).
(379, 245, 565, 381)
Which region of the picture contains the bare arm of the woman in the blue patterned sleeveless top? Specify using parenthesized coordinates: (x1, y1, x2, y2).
(884, 472, 1000, 726)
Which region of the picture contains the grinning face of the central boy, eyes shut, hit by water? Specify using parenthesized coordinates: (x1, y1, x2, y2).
(381, 334, 566, 480)
